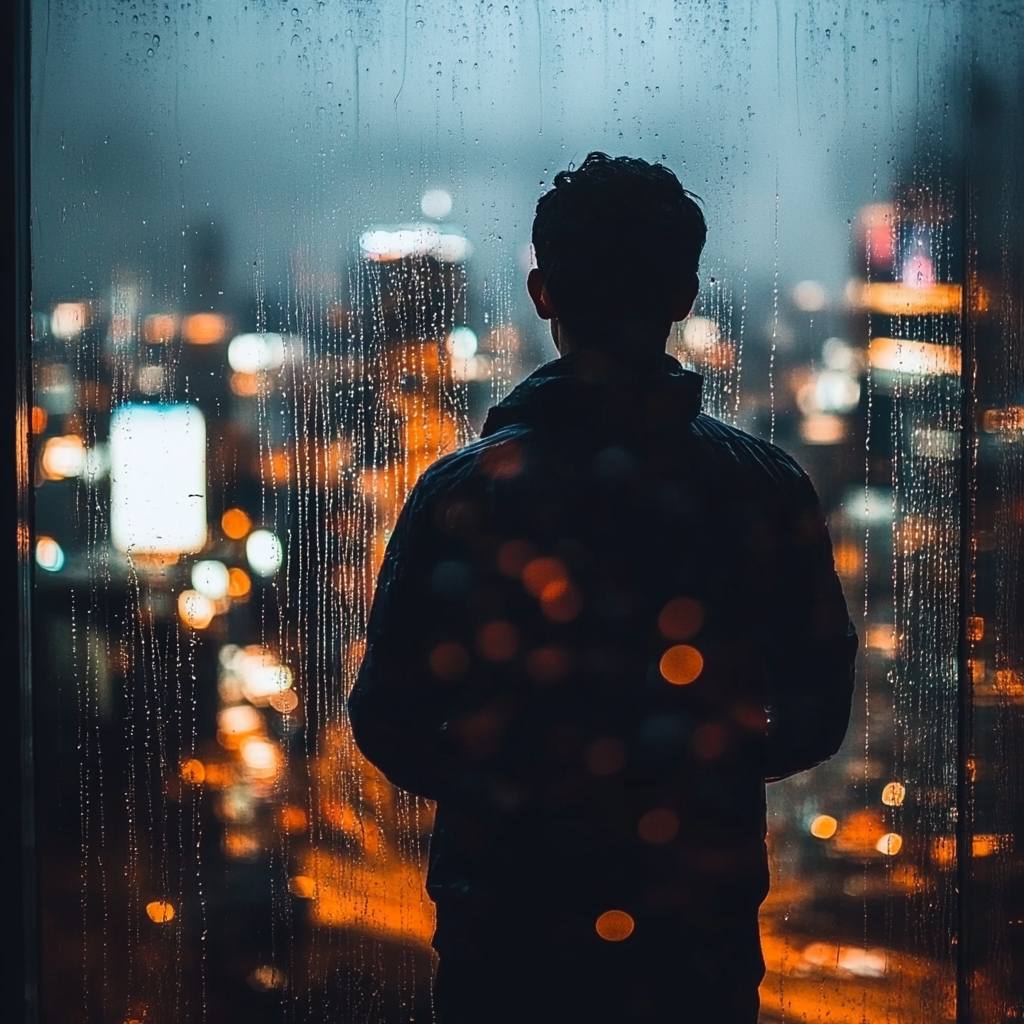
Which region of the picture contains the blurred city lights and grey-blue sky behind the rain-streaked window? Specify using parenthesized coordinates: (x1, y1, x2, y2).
(22, 0, 1024, 1024)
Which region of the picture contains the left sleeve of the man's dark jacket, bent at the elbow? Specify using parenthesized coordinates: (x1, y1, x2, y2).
(348, 487, 446, 798)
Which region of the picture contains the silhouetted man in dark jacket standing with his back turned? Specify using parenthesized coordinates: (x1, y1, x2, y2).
(349, 153, 857, 1024)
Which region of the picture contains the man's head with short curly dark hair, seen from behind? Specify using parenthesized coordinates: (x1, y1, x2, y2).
(527, 153, 708, 355)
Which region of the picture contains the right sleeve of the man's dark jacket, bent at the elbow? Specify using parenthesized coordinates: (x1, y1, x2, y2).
(765, 471, 857, 781)
